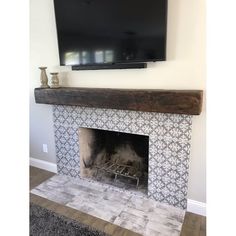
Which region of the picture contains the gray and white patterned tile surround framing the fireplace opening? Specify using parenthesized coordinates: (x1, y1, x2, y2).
(53, 105, 192, 209)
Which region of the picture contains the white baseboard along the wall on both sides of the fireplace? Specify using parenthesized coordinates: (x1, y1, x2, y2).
(30, 157, 206, 216)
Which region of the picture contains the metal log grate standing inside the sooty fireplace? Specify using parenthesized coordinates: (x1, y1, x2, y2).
(95, 161, 142, 188)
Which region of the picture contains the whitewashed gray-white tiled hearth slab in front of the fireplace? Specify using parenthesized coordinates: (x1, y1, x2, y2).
(31, 175, 185, 236)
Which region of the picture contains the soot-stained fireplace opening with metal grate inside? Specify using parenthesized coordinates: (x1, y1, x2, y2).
(79, 128, 149, 193)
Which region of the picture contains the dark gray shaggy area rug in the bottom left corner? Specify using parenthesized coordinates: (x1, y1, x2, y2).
(30, 203, 106, 236)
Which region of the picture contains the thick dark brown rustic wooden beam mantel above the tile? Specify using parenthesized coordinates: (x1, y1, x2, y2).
(34, 87, 203, 115)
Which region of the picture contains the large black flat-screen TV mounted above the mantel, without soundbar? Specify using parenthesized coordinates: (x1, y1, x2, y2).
(54, 0, 167, 66)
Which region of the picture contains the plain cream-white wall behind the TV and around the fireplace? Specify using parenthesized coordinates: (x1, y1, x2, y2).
(30, 0, 206, 202)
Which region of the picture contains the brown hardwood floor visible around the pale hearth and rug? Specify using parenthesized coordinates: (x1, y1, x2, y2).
(30, 167, 206, 236)
